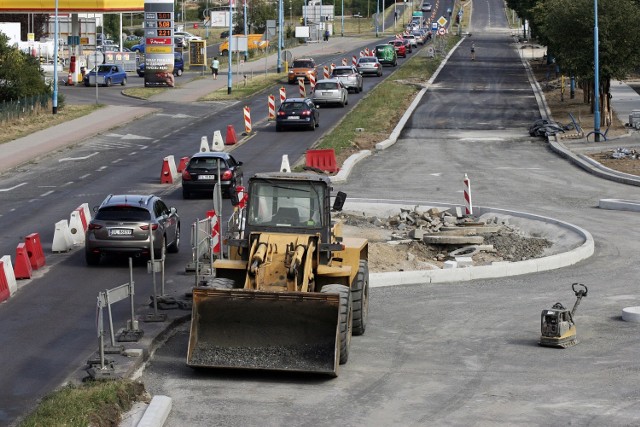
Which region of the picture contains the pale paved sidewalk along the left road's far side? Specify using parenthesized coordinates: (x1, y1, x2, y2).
(0, 37, 377, 173)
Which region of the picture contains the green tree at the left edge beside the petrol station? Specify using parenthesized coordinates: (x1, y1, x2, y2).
(0, 34, 51, 102)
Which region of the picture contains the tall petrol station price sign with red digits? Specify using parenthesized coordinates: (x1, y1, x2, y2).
(144, 0, 174, 87)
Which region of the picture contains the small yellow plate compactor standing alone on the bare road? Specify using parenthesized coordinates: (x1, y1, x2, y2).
(540, 283, 588, 348)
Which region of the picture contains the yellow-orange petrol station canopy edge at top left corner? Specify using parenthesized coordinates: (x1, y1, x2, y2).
(0, 0, 144, 13)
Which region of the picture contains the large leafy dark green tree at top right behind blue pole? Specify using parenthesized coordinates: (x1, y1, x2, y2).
(533, 0, 640, 125)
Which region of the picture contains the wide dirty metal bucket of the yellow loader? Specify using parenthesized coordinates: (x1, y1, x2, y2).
(187, 288, 340, 376)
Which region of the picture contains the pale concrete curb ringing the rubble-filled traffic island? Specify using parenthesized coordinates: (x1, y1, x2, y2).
(345, 199, 595, 288)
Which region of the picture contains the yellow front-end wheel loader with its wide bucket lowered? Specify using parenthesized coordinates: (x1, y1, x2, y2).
(187, 172, 369, 376)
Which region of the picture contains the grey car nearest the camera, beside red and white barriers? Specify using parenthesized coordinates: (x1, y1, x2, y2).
(85, 194, 180, 265)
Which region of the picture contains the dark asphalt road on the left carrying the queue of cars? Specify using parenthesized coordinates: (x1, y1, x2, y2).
(0, 35, 420, 425)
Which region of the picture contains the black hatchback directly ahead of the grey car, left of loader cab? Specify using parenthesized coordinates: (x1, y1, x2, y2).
(182, 151, 243, 199)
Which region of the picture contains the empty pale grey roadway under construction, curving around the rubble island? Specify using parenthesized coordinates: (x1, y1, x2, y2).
(135, 0, 640, 426)
